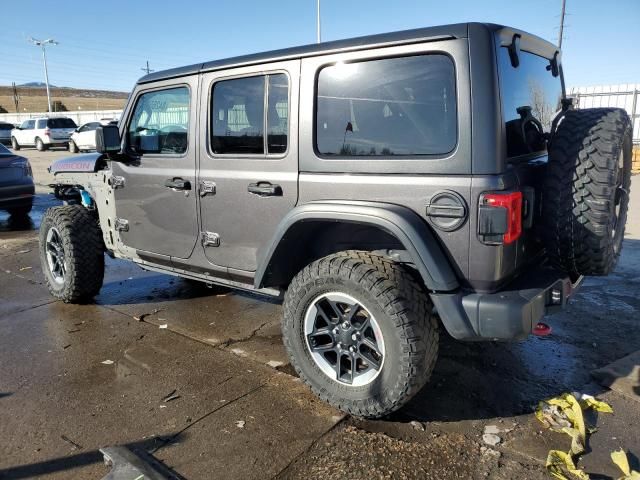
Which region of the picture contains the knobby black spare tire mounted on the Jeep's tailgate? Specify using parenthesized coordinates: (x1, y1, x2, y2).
(541, 108, 632, 277)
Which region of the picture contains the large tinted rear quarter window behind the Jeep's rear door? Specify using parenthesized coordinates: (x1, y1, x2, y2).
(316, 54, 457, 157)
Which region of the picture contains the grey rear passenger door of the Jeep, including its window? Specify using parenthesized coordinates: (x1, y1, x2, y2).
(199, 60, 300, 280)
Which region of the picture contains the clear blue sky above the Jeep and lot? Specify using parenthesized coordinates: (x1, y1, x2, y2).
(0, 0, 640, 91)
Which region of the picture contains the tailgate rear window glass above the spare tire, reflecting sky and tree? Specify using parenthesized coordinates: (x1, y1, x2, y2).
(498, 47, 562, 157)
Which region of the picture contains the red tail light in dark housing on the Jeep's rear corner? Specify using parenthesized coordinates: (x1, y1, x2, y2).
(478, 192, 522, 245)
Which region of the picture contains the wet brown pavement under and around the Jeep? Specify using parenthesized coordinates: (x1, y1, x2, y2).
(0, 151, 640, 479)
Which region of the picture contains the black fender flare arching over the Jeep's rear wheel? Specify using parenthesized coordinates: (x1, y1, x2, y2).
(254, 200, 459, 292)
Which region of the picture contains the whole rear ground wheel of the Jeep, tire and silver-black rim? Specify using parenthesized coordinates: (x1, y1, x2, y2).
(282, 251, 438, 418)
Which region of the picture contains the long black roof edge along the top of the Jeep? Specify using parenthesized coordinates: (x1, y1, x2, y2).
(138, 23, 484, 83)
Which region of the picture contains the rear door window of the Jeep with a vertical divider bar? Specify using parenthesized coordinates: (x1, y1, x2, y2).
(211, 73, 289, 155)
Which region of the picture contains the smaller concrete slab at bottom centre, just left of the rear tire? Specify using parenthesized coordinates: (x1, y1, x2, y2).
(154, 374, 342, 480)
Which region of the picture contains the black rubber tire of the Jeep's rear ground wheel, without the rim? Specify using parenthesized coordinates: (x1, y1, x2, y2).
(282, 251, 439, 418)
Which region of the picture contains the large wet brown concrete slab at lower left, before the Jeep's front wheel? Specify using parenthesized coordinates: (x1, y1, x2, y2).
(0, 303, 276, 478)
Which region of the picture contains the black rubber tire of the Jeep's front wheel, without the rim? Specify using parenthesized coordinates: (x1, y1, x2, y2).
(40, 205, 104, 303)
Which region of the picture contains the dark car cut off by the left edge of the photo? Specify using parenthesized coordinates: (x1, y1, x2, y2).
(0, 141, 35, 216)
